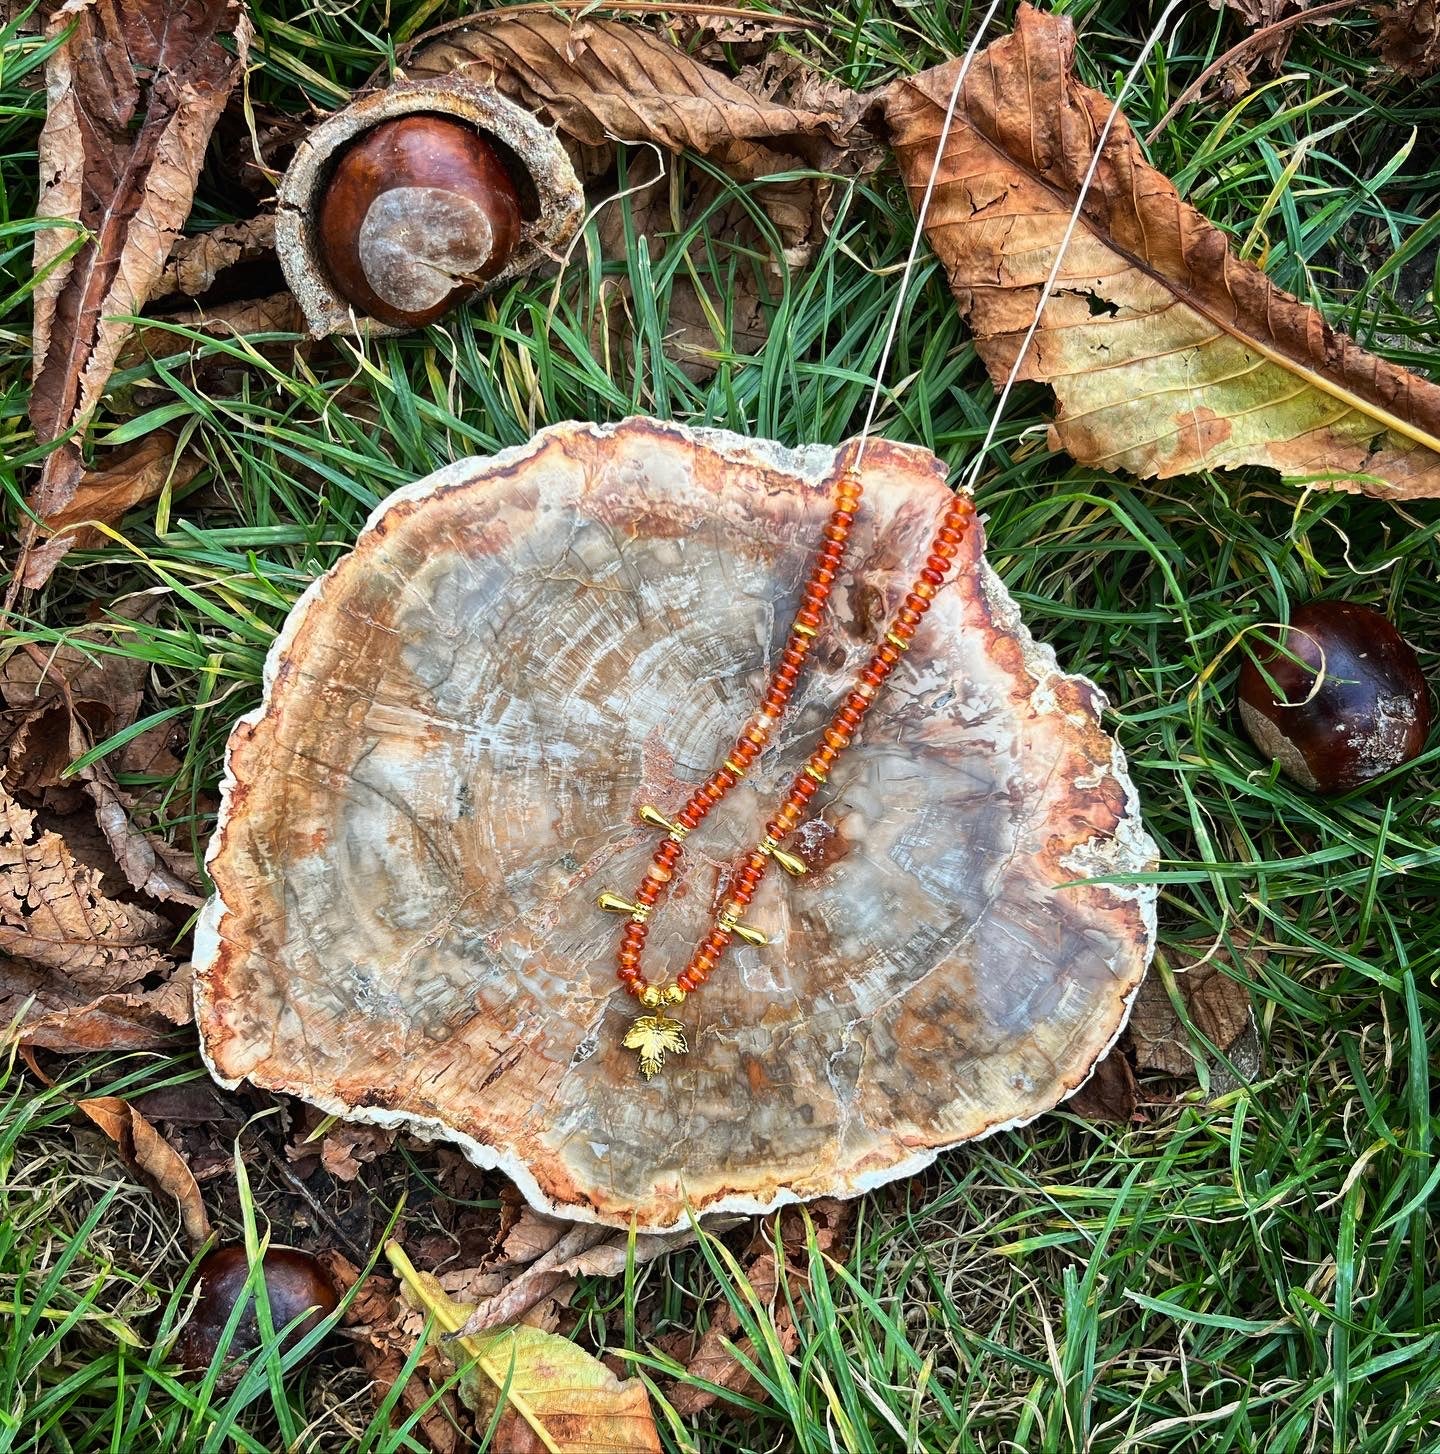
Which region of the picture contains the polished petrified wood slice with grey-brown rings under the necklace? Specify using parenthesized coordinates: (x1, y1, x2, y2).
(196, 420, 1153, 1229)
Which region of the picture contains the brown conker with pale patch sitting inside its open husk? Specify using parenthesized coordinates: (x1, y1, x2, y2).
(316, 113, 521, 329)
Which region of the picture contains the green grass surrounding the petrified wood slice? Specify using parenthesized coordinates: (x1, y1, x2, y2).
(0, 0, 1440, 1454)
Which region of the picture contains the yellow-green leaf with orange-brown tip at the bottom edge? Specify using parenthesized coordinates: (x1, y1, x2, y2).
(385, 1242, 660, 1454)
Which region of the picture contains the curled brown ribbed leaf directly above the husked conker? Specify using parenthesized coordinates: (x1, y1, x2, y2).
(406, 13, 868, 250)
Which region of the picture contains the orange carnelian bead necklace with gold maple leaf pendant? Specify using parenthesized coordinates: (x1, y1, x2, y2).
(598, 464, 975, 1079)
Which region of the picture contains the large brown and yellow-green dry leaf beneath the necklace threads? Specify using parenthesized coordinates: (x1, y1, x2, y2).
(883, 6, 1440, 497)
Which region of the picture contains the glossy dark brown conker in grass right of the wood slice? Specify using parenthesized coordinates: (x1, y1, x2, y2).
(1239, 601, 1430, 792)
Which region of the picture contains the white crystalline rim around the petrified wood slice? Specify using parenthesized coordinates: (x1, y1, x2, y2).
(195, 419, 1159, 1233)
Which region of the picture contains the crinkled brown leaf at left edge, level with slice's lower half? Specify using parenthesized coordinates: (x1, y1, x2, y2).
(0, 788, 173, 995)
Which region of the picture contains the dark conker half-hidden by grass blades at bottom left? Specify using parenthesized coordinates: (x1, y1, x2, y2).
(175, 1246, 336, 1373)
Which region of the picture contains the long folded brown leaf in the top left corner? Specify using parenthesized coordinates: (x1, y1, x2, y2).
(31, 0, 250, 578)
